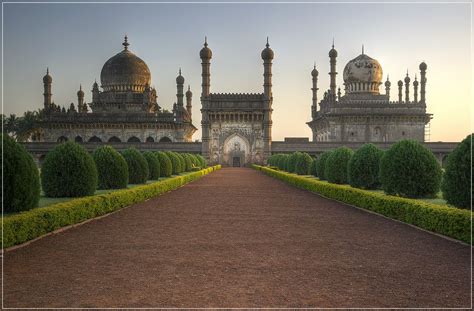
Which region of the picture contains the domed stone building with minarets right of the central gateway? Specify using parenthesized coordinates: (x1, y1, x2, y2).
(307, 45, 432, 142)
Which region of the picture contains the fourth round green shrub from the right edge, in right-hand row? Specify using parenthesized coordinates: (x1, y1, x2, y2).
(324, 147, 354, 184)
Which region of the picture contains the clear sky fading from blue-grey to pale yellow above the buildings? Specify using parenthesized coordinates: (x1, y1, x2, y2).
(2, 3, 473, 141)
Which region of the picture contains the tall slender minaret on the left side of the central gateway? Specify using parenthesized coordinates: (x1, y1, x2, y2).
(199, 37, 212, 160)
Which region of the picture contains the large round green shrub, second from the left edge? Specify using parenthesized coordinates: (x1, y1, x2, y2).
(41, 142, 98, 197)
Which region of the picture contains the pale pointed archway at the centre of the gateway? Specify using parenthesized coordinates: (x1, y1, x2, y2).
(222, 133, 251, 167)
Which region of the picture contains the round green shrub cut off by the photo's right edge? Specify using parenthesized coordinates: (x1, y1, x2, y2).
(441, 134, 473, 209)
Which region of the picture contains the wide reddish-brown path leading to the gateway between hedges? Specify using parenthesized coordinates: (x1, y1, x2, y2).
(4, 168, 470, 307)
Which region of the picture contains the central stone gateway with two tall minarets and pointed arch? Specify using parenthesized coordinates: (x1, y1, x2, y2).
(200, 40, 274, 166)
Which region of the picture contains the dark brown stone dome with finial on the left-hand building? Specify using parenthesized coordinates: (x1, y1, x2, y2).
(100, 37, 151, 92)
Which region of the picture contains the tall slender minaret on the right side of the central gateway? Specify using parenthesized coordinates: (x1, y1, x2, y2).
(261, 37, 275, 163)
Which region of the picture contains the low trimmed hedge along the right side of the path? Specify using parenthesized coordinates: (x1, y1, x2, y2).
(254, 165, 472, 243)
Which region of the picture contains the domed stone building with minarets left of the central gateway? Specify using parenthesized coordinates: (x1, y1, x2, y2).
(41, 37, 197, 143)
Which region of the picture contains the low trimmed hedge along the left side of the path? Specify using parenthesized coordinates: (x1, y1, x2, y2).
(2, 165, 221, 248)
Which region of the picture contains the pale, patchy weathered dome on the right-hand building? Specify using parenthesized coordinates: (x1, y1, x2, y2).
(343, 53, 383, 93)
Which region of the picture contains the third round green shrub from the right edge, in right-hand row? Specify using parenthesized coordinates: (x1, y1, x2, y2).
(348, 144, 383, 189)
